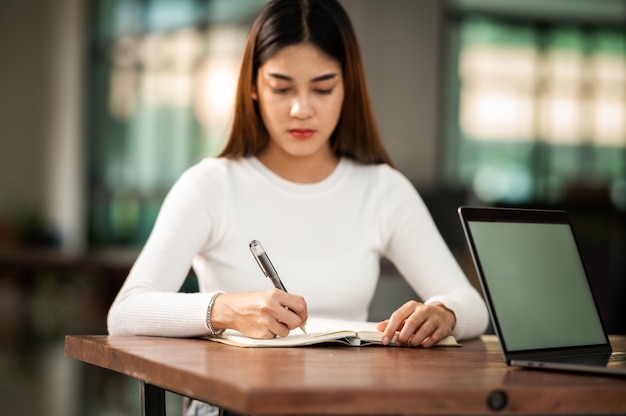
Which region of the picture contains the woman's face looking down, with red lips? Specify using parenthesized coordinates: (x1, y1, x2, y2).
(253, 44, 344, 161)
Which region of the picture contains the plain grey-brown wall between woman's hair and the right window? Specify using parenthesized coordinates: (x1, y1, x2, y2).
(341, 0, 444, 188)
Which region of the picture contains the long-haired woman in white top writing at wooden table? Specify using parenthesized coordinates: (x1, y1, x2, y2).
(108, 0, 487, 347)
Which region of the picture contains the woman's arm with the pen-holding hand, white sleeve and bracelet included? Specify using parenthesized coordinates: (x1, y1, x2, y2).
(107, 162, 307, 338)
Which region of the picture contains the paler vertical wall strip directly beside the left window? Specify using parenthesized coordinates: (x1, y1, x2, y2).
(44, 0, 87, 250)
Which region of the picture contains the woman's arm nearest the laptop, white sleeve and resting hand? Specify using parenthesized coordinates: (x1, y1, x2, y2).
(379, 170, 488, 346)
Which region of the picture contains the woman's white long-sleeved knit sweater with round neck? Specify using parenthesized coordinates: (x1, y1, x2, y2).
(108, 158, 488, 339)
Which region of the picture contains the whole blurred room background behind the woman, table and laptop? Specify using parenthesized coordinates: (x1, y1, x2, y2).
(0, 0, 626, 416)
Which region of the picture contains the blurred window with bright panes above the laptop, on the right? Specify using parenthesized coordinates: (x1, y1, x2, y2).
(446, 14, 626, 209)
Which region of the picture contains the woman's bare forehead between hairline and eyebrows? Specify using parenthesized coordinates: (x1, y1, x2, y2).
(259, 43, 341, 80)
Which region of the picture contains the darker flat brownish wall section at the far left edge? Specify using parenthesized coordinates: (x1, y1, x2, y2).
(0, 1, 49, 221)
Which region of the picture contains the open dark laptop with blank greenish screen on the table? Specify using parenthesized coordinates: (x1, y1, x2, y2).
(458, 207, 626, 376)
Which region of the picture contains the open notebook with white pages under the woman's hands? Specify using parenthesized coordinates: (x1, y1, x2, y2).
(203, 317, 460, 347)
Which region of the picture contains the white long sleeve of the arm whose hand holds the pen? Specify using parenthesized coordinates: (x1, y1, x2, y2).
(107, 164, 221, 337)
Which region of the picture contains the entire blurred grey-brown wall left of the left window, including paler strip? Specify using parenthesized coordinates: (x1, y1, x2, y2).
(0, 0, 87, 249)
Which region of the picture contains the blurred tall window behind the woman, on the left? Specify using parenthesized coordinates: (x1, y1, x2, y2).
(88, 0, 265, 247)
